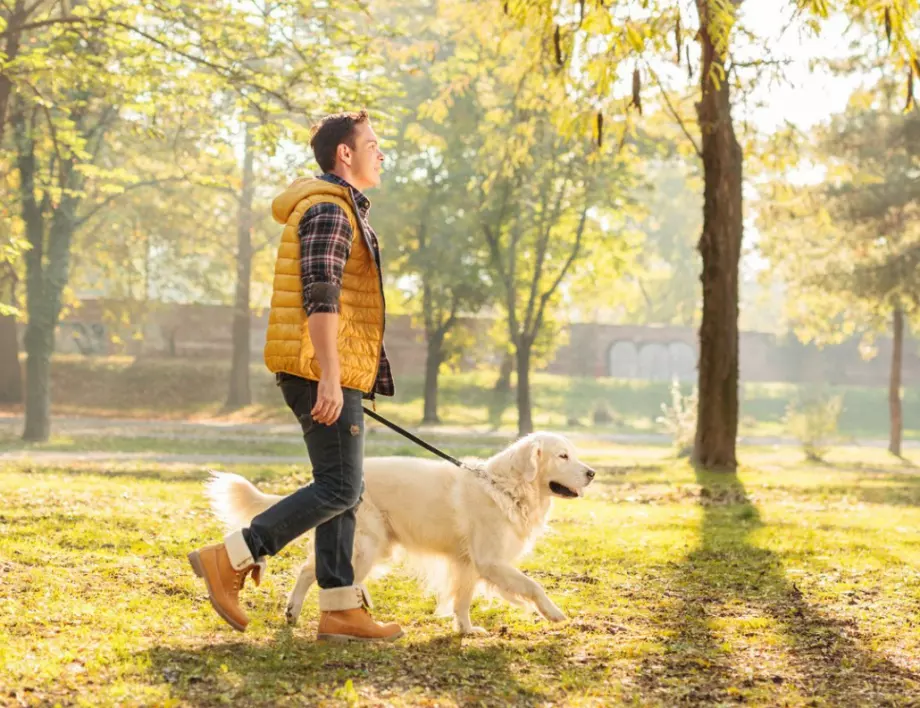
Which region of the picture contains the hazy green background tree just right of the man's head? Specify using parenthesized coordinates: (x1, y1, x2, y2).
(374, 11, 492, 423)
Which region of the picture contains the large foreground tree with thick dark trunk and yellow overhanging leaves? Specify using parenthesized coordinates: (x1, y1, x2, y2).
(503, 0, 920, 469)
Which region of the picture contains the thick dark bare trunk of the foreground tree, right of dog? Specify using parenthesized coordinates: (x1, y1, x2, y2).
(693, 0, 743, 470)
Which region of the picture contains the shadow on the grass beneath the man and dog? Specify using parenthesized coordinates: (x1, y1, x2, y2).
(145, 628, 562, 706)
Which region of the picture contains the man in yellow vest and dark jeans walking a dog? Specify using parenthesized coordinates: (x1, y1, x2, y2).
(189, 111, 402, 640)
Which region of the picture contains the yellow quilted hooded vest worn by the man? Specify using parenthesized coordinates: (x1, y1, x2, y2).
(265, 178, 384, 393)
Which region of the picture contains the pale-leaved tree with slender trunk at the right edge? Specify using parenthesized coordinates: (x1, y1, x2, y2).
(762, 95, 920, 455)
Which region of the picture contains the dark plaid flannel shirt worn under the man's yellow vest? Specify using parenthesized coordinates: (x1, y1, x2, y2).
(297, 169, 395, 398)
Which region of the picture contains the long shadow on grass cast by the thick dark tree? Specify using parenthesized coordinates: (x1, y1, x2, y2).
(639, 471, 920, 706)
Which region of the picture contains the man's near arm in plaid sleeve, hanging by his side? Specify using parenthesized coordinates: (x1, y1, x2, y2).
(298, 203, 352, 425)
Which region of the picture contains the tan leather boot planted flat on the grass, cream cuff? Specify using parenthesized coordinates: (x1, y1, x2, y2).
(316, 585, 403, 642)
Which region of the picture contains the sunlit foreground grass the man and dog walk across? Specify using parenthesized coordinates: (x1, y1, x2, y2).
(0, 440, 920, 706)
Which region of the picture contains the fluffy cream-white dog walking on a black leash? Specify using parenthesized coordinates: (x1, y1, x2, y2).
(208, 433, 594, 634)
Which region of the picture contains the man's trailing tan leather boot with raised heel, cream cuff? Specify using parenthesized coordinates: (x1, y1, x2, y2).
(188, 531, 265, 632)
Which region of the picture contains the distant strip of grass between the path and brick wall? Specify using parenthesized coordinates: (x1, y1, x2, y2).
(3, 356, 920, 439)
